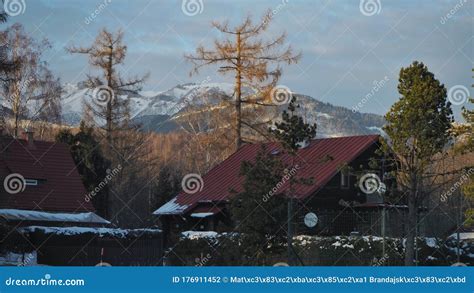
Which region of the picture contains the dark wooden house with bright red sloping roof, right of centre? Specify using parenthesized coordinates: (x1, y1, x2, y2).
(154, 135, 406, 236)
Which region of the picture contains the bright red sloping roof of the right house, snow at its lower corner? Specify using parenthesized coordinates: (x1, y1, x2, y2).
(155, 135, 379, 214)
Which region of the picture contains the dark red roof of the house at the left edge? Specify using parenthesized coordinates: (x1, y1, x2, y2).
(0, 137, 94, 212)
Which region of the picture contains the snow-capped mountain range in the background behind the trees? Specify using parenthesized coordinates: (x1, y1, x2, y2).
(62, 82, 384, 137)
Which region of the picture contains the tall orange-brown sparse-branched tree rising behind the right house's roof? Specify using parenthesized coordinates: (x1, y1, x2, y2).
(185, 11, 300, 148)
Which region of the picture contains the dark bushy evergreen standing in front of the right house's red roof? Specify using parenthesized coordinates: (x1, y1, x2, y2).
(231, 147, 286, 264)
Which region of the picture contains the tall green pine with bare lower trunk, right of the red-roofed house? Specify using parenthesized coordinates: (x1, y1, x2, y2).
(382, 61, 453, 265)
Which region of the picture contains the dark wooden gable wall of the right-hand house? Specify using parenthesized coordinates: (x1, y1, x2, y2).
(295, 145, 406, 237)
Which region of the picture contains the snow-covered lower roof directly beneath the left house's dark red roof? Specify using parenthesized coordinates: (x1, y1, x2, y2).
(0, 209, 110, 224)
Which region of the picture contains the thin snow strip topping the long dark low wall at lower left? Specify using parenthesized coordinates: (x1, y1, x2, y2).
(18, 226, 162, 238)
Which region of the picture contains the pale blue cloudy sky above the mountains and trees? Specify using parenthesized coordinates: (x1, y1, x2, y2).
(3, 0, 474, 119)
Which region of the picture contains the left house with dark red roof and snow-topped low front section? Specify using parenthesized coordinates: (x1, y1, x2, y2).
(0, 130, 162, 265)
